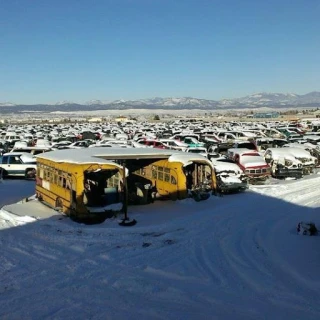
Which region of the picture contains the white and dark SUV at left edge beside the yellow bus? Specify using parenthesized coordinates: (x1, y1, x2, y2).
(0, 152, 37, 179)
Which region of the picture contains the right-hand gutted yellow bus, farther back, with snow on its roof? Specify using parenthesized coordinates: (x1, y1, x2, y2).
(92, 148, 217, 200)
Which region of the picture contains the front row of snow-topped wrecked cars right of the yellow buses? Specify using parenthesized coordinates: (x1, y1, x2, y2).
(210, 142, 320, 192)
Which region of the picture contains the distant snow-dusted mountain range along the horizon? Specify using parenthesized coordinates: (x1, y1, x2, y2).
(0, 91, 320, 113)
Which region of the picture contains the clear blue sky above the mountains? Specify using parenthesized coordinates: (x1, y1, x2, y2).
(0, 0, 320, 104)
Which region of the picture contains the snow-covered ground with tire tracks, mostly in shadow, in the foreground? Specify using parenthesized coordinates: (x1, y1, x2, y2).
(0, 175, 320, 320)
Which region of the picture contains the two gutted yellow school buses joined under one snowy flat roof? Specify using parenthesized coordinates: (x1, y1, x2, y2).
(36, 147, 216, 219)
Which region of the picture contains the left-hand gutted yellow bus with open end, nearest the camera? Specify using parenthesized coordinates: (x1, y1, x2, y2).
(36, 148, 123, 218)
